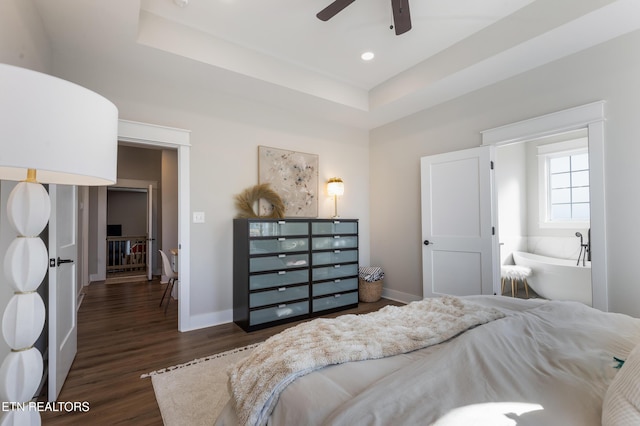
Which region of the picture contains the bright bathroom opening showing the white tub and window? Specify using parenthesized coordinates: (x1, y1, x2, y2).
(495, 128, 593, 306)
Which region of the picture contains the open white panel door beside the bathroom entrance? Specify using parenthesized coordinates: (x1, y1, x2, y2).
(421, 146, 495, 297)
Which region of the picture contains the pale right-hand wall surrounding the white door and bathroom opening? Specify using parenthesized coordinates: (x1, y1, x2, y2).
(371, 32, 640, 316)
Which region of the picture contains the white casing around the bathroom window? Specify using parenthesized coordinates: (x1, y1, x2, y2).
(538, 137, 591, 229)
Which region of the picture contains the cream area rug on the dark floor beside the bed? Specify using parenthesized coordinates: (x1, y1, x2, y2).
(141, 344, 258, 426)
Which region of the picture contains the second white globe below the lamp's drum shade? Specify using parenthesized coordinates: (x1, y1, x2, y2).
(4, 238, 49, 292)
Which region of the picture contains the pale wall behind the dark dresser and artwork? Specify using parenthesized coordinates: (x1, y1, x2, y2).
(45, 48, 369, 325)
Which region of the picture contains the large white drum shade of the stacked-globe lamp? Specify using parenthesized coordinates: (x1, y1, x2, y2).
(0, 64, 118, 185)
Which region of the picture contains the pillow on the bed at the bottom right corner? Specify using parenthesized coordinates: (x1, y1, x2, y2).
(602, 344, 640, 426)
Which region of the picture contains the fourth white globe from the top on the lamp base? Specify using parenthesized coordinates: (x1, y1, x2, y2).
(0, 348, 44, 402)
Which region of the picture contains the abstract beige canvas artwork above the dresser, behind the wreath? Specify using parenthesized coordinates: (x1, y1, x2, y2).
(258, 146, 318, 217)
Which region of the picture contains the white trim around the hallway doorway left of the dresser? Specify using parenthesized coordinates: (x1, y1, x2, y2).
(118, 120, 192, 331)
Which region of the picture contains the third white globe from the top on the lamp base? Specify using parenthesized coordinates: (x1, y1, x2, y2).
(2, 293, 46, 352)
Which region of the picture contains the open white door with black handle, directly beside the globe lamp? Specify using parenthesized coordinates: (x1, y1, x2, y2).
(48, 185, 78, 401)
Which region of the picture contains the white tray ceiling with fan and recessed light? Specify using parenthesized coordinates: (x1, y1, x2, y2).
(35, 0, 640, 129)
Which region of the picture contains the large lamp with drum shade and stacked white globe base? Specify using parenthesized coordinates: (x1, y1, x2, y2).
(0, 64, 118, 426)
